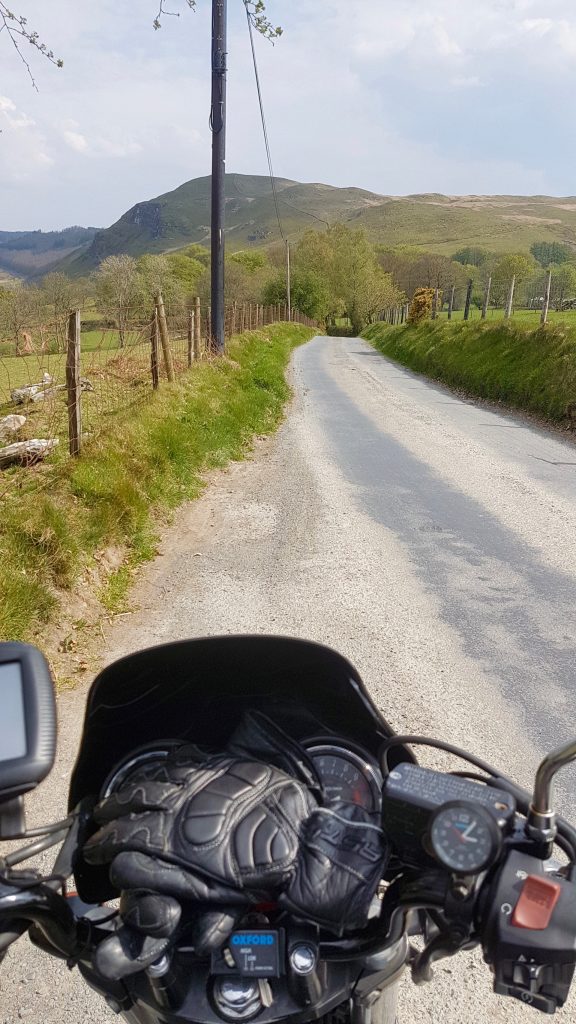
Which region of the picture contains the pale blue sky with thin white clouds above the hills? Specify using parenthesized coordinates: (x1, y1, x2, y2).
(0, 0, 576, 230)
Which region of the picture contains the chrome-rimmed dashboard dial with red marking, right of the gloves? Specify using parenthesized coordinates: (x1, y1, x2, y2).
(307, 743, 382, 814)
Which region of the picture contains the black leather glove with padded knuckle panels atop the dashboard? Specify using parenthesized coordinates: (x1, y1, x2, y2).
(84, 758, 317, 904)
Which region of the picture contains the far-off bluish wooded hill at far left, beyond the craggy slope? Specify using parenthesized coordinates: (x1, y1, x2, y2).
(0, 226, 97, 276)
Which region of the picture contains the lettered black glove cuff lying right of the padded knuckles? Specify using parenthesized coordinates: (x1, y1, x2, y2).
(280, 803, 389, 935)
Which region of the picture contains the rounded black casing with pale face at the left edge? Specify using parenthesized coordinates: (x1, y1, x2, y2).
(0, 643, 56, 815)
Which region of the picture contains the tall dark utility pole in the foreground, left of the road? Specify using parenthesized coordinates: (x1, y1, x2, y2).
(210, 0, 227, 353)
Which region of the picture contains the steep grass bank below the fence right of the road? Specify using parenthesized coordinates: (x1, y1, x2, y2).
(363, 321, 576, 423)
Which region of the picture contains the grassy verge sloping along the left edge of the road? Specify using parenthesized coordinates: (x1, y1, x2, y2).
(0, 324, 314, 639)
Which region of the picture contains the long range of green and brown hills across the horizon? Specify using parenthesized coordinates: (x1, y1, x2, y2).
(8, 174, 576, 275)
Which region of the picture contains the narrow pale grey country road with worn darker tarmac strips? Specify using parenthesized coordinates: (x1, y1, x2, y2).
(0, 338, 576, 1024)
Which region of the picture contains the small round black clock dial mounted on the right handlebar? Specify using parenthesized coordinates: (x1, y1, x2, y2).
(428, 800, 502, 874)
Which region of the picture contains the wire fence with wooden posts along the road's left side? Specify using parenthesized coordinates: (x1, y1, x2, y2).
(0, 297, 316, 498)
